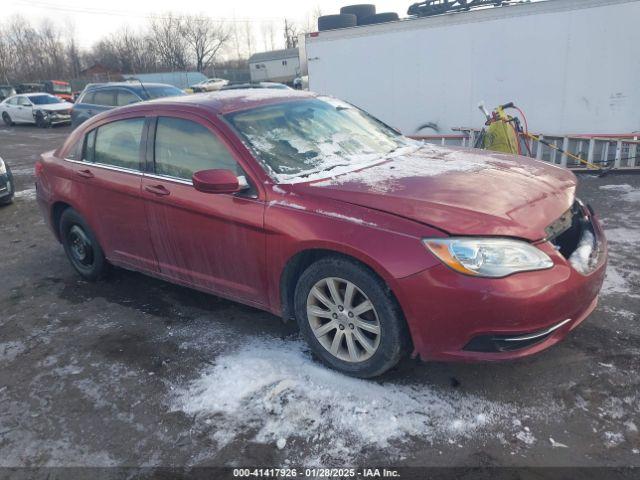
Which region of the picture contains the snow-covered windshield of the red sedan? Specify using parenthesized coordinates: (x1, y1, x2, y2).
(225, 98, 412, 181)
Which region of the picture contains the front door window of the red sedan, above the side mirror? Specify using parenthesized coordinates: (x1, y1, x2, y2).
(155, 117, 242, 180)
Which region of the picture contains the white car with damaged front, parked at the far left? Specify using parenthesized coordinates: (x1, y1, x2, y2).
(0, 93, 73, 128)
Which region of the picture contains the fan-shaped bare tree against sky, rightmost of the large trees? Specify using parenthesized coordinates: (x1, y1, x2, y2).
(181, 16, 231, 72)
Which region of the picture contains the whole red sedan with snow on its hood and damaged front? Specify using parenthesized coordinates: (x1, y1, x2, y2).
(36, 90, 606, 377)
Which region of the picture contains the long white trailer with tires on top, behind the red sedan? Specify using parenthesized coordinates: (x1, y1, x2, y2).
(300, 0, 640, 136)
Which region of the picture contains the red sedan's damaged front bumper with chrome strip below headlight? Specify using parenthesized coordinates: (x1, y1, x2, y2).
(394, 203, 607, 361)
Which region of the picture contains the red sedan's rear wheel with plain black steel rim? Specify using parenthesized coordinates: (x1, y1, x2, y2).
(60, 208, 109, 281)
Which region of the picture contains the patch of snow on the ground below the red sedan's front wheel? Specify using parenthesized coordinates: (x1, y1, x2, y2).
(174, 340, 515, 456)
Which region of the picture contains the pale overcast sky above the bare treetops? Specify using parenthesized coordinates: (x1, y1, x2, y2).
(8, 0, 412, 50)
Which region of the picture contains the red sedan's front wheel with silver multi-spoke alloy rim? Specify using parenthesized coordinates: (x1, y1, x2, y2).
(294, 257, 409, 378)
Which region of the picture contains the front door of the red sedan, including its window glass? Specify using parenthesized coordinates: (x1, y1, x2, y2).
(142, 113, 267, 305)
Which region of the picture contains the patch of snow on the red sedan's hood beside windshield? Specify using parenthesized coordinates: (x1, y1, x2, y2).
(315, 145, 484, 192)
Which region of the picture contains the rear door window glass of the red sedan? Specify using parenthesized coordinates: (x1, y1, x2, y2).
(91, 118, 144, 170)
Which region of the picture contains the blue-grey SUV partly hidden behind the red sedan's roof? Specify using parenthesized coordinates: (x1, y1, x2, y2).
(71, 82, 185, 128)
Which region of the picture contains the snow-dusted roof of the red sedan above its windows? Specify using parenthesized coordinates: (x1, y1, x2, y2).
(141, 88, 317, 114)
